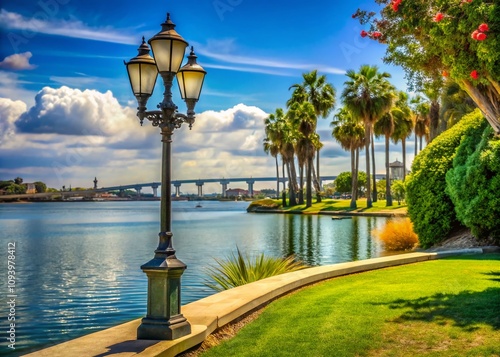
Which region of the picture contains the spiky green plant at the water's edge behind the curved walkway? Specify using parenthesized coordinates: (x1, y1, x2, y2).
(204, 248, 307, 291)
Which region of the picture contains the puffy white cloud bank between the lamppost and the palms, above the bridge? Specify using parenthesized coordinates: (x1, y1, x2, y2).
(168, 104, 274, 181)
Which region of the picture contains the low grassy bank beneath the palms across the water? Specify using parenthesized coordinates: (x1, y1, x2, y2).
(249, 199, 406, 213)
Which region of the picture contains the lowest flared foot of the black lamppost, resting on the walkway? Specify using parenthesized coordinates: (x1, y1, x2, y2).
(137, 315, 191, 340)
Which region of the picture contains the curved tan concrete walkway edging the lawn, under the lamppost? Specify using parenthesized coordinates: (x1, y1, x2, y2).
(27, 248, 485, 357)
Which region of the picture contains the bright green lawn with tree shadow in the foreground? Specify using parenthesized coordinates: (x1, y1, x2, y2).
(202, 254, 500, 357)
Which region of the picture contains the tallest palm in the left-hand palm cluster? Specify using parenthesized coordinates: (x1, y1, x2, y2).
(286, 70, 335, 202)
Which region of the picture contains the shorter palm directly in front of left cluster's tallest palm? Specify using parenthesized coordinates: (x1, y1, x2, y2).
(288, 102, 317, 207)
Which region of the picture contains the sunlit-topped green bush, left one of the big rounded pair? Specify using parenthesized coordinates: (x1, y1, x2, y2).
(406, 109, 487, 248)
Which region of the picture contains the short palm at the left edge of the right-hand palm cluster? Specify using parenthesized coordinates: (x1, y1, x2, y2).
(330, 107, 365, 209)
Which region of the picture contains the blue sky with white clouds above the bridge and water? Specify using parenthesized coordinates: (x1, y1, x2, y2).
(0, 0, 413, 192)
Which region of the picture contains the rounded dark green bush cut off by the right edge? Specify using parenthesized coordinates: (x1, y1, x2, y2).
(446, 127, 500, 241)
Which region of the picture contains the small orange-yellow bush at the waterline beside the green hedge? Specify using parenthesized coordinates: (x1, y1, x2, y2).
(373, 218, 418, 251)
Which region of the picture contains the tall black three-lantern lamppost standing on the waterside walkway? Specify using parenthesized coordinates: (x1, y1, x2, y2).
(125, 14, 206, 340)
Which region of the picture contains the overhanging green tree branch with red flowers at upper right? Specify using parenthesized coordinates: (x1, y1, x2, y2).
(352, 0, 500, 134)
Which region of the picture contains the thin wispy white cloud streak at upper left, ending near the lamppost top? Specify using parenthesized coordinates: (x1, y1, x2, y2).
(0, 9, 137, 45)
